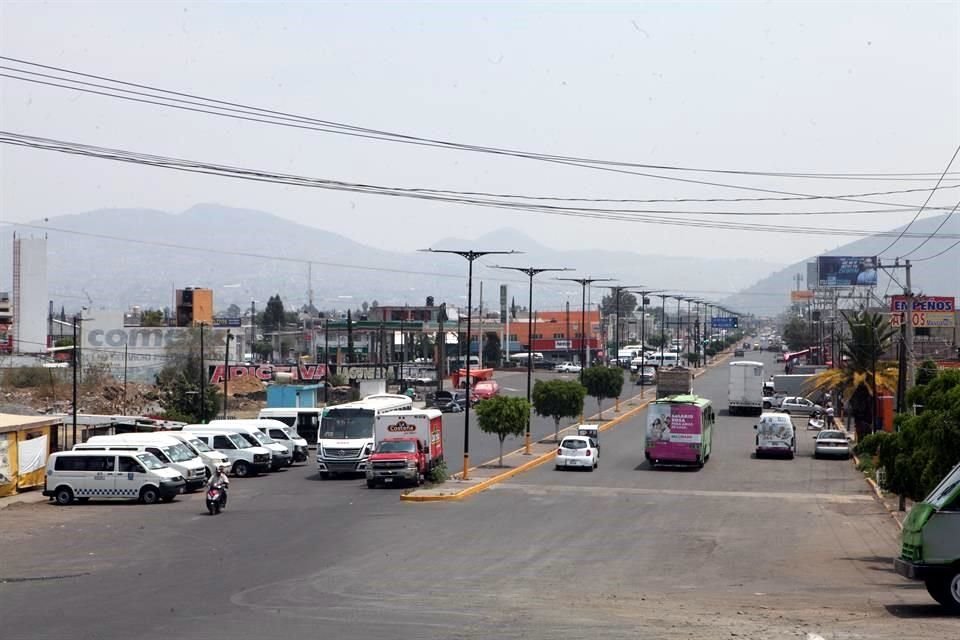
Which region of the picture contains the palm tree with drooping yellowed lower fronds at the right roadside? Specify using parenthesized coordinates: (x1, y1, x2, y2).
(807, 310, 898, 439)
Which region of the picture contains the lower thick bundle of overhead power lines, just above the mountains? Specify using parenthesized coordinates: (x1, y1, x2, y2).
(0, 131, 960, 239)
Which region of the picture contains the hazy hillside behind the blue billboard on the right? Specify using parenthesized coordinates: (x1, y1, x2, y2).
(723, 214, 960, 315)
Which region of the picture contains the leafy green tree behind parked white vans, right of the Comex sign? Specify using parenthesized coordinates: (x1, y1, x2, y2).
(157, 328, 222, 422)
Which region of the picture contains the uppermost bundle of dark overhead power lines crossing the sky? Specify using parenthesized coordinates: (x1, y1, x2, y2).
(0, 56, 960, 188)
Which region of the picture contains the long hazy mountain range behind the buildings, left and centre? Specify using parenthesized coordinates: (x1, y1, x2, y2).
(0, 204, 780, 310)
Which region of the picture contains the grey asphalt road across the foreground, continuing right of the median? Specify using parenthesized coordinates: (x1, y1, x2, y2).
(0, 352, 960, 640)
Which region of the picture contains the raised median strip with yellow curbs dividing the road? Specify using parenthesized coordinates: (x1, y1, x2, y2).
(400, 351, 731, 502)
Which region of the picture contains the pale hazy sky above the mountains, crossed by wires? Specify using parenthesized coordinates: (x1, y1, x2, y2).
(0, 1, 960, 263)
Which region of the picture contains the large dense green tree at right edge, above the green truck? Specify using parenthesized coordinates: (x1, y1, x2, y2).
(864, 370, 960, 500)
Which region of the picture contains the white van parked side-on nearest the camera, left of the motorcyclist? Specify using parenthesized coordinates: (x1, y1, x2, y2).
(43, 450, 185, 505)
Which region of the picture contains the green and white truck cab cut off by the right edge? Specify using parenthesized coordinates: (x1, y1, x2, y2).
(893, 464, 960, 614)
